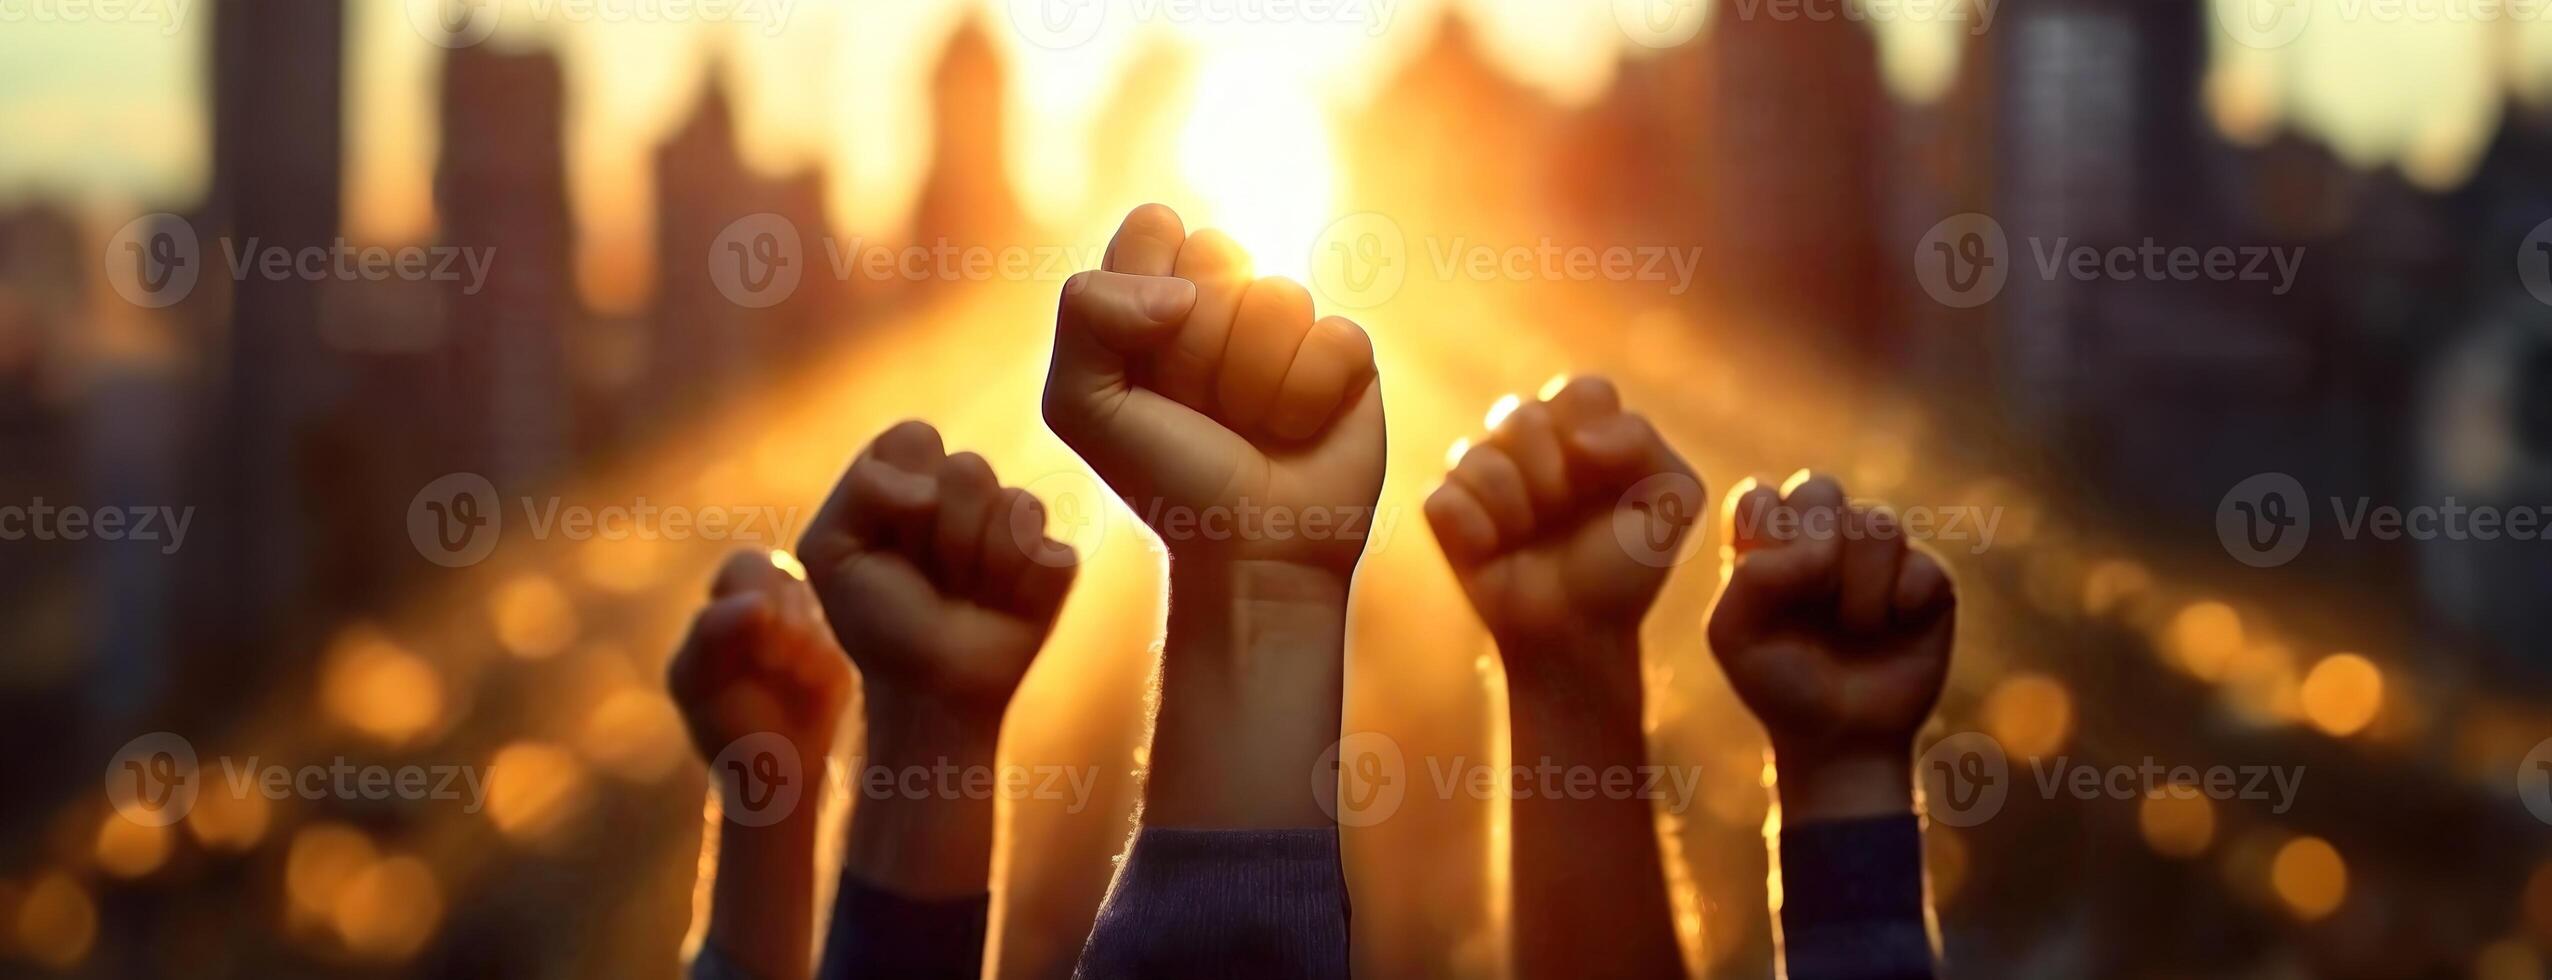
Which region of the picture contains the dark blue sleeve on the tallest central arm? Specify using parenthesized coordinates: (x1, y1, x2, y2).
(1074, 827, 1347, 980)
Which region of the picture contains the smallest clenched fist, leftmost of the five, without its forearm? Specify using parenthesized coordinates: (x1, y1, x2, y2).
(666, 551, 850, 758)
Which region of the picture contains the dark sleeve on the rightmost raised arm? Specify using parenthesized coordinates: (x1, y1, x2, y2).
(1781, 814, 1932, 980)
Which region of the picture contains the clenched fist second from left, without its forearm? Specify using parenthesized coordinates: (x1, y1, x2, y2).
(799, 421, 1079, 722)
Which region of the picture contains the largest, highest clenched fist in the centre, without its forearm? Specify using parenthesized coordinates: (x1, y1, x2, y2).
(1044, 204, 1383, 574)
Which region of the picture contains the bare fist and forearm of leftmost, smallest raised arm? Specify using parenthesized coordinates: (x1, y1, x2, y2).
(666, 551, 850, 977)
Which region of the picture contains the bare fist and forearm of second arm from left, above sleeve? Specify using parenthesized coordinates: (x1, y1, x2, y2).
(799, 421, 1079, 901)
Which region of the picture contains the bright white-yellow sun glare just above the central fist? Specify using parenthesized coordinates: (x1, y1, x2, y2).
(1179, 59, 1337, 281)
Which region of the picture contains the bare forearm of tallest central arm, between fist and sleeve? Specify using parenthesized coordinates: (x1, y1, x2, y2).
(1143, 561, 1347, 829)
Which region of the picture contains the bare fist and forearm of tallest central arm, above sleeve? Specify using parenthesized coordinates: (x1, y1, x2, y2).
(1044, 204, 1383, 827)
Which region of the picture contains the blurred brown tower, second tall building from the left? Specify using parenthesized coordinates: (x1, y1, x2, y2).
(434, 46, 577, 490)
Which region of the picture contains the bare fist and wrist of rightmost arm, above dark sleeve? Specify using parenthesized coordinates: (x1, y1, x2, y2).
(1710, 475, 1957, 822)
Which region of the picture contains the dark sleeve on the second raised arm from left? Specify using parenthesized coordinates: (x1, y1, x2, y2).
(817, 870, 993, 980)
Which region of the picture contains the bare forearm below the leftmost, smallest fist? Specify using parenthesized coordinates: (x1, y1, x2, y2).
(704, 806, 817, 980)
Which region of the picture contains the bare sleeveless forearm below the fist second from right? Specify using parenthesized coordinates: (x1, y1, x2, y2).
(1498, 633, 1684, 977)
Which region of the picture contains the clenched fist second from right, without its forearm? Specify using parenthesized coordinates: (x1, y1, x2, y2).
(1427, 378, 1707, 653)
